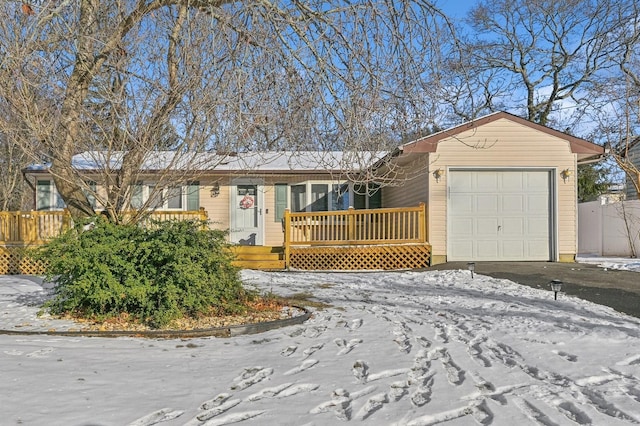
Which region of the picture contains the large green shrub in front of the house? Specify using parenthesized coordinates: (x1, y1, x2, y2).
(36, 217, 254, 327)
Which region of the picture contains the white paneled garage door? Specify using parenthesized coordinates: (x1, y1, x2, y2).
(447, 170, 552, 261)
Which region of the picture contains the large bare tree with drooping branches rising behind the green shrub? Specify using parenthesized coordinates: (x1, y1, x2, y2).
(0, 0, 460, 220)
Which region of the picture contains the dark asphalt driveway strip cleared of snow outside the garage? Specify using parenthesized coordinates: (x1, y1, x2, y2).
(429, 262, 640, 318)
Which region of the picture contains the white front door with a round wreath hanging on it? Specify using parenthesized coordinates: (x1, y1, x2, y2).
(229, 182, 263, 246)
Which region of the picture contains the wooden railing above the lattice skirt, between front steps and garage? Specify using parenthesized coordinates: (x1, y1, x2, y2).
(283, 203, 426, 265)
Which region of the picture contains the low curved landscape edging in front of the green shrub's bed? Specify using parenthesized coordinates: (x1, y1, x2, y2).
(0, 306, 312, 339)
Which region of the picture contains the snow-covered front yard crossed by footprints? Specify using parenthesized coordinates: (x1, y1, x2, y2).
(0, 258, 640, 426)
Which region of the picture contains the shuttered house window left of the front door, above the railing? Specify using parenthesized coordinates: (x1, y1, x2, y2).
(131, 182, 200, 210)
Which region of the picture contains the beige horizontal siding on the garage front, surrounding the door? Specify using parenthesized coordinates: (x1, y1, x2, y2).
(424, 119, 577, 260)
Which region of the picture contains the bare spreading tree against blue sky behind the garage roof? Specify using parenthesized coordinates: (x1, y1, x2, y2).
(466, 0, 637, 128)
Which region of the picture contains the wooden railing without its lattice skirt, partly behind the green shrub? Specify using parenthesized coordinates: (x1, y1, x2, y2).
(0, 208, 207, 245)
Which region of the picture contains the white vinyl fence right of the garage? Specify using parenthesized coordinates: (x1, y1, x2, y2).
(578, 200, 640, 257)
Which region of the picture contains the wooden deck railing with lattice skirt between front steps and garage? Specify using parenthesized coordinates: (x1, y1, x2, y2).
(283, 204, 431, 270)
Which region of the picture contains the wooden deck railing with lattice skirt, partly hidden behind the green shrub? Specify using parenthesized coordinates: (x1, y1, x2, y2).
(0, 208, 207, 275)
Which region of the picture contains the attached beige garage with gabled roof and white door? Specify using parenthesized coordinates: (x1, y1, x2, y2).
(382, 112, 605, 264)
